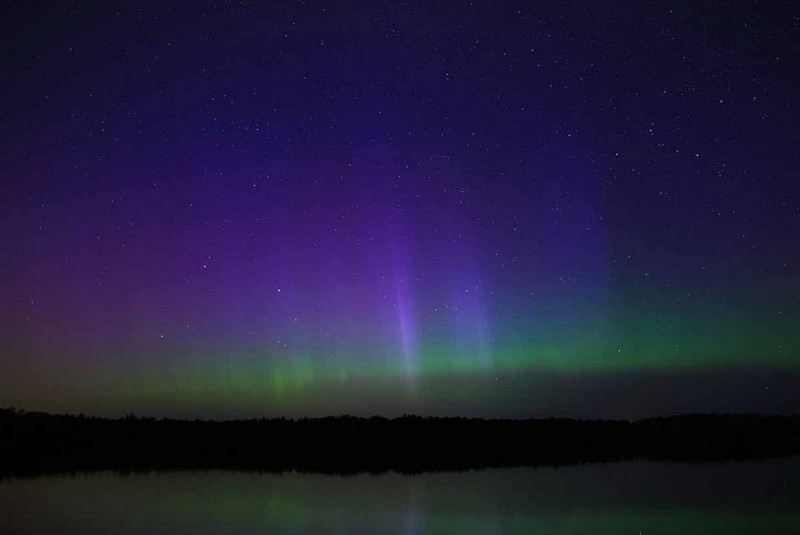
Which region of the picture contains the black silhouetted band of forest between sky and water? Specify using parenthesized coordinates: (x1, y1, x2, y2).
(0, 408, 800, 476)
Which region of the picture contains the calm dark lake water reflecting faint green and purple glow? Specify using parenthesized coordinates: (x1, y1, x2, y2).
(0, 457, 800, 535)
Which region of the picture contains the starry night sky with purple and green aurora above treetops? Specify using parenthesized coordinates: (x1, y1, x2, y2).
(0, 1, 800, 417)
